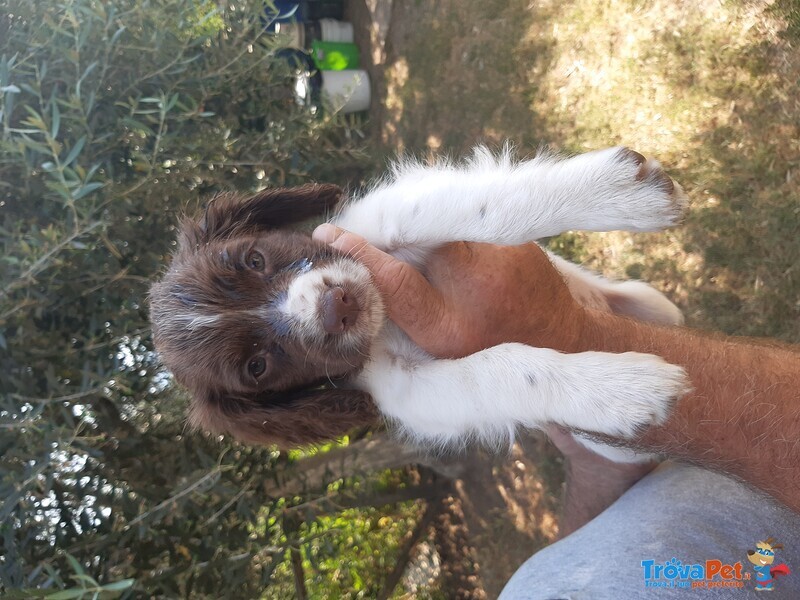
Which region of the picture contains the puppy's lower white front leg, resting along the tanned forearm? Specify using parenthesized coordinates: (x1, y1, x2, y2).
(359, 343, 688, 446)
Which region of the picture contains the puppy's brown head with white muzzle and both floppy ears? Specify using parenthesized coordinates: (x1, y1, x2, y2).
(150, 185, 384, 446)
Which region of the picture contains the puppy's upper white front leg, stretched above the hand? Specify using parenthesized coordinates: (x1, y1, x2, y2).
(335, 147, 686, 250)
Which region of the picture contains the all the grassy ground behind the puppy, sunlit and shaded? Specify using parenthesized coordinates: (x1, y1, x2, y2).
(348, 0, 800, 597)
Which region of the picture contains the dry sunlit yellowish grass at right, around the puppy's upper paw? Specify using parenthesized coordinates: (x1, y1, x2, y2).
(531, 1, 800, 341)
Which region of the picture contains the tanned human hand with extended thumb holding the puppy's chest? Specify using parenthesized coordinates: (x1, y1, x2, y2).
(314, 224, 585, 358)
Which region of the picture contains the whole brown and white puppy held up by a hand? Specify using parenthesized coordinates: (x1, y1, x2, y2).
(150, 148, 687, 459)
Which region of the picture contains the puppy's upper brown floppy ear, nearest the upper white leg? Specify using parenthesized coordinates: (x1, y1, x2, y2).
(197, 183, 343, 242)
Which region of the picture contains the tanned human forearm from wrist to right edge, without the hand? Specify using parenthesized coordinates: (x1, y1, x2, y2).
(578, 311, 800, 510)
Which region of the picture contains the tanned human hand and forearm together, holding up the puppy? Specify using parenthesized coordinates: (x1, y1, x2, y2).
(315, 226, 800, 511)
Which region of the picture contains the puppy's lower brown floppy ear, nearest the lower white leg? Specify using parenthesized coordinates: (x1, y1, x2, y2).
(189, 388, 379, 448)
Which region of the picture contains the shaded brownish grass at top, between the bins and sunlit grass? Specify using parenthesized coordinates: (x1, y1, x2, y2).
(366, 0, 552, 154)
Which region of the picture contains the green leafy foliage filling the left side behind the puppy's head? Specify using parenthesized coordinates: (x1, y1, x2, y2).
(0, 0, 382, 598)
